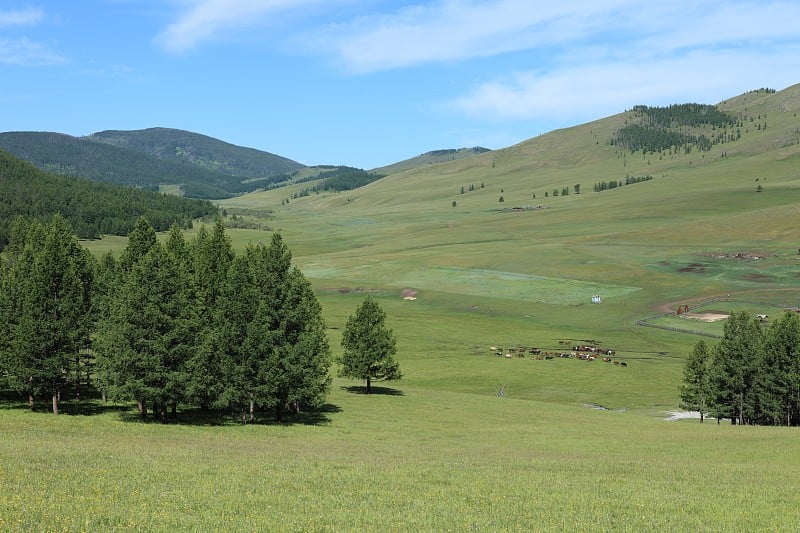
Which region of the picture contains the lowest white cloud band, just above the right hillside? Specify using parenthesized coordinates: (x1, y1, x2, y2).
(450, 46, 800, 123)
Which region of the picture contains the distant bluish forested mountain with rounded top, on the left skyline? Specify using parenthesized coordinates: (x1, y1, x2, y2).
(0, 128, 304, 199)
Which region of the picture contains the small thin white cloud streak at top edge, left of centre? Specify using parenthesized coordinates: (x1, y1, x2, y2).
(156, 0, 324, 52)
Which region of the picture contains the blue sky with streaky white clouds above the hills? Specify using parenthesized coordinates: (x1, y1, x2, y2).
(0, 0, 800, 169)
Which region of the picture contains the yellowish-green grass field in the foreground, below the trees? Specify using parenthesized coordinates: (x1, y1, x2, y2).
(0, 380, 800, 532)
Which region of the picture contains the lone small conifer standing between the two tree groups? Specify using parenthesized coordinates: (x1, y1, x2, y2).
(339, 296, 402, 394)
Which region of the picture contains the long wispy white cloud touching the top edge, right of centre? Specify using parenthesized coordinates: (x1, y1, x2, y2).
(321, 0, 634, 72)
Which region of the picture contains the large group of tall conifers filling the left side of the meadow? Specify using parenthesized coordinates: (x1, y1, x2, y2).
(0, 216, 330, 421)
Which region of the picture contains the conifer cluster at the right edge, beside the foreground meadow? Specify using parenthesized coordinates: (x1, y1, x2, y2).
(681, 311, 800, 426)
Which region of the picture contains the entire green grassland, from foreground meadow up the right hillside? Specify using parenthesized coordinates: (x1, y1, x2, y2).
(0, 86, 800, 531)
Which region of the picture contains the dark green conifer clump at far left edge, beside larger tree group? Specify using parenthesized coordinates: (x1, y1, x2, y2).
(0, 215, 93, 414)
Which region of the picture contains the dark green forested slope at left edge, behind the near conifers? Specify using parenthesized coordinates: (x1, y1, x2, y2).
(0, 150, 217, 249)
